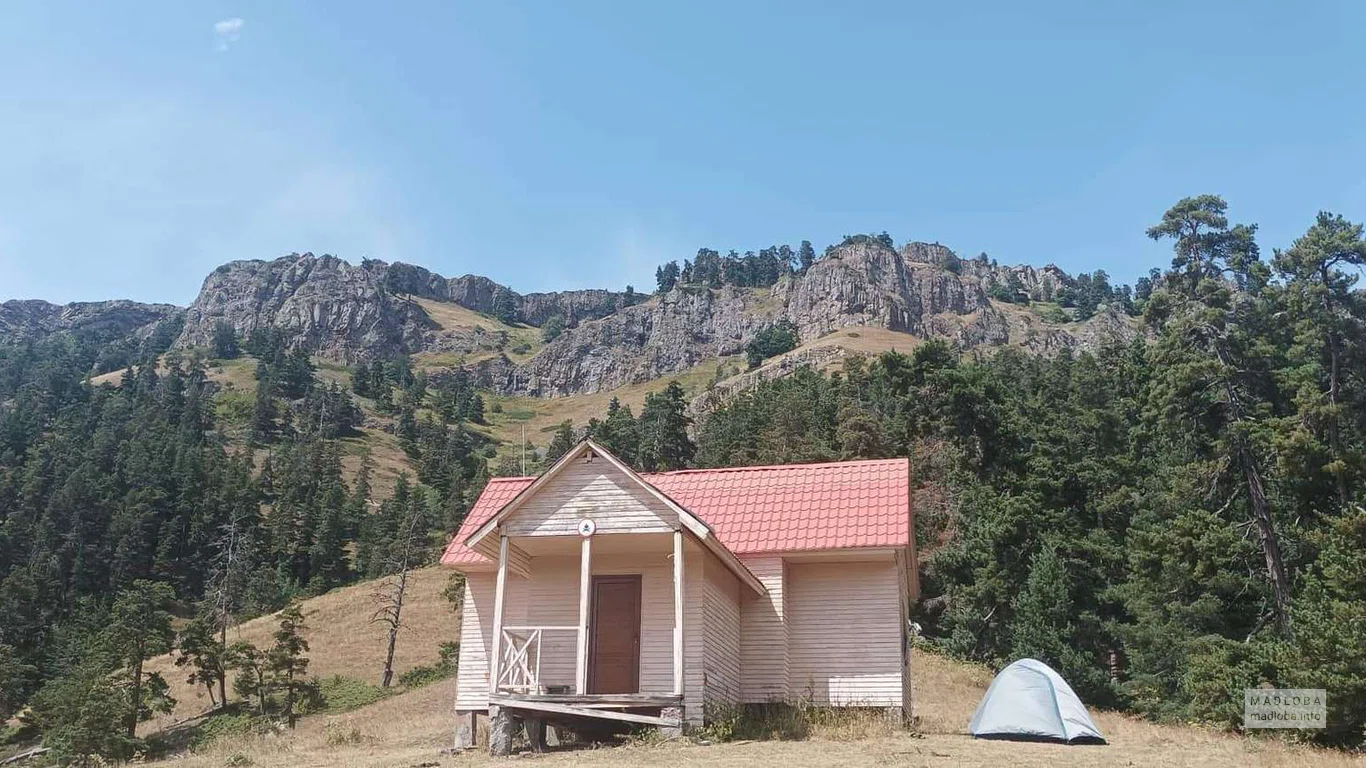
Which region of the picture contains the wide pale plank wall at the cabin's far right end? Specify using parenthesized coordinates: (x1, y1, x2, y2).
(787, 562, 902, 707)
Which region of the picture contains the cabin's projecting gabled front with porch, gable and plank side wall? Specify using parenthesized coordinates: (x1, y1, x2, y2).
(445, 440, 765, 752)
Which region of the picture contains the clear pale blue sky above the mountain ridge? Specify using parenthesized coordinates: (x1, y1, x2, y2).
(0, 0, 1366, 303)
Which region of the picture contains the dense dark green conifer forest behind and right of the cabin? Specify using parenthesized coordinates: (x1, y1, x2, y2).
(695, 195, 1366, 745)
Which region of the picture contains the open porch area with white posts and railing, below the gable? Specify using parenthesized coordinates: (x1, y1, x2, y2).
(489, 525, 698, 748)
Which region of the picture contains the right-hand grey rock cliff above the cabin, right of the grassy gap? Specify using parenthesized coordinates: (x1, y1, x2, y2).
(497, 242, 1137, 396)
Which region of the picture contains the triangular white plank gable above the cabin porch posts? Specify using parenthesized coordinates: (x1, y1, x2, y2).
(504, 459, 678, 536)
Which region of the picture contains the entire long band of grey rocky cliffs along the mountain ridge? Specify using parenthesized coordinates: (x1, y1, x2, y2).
(8, 238, 1137, 398)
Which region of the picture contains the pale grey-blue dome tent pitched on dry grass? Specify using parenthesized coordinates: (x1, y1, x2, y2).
(967, 650, 1105, 743)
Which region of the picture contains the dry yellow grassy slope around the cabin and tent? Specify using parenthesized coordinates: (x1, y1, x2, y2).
(143, 568, 1361, 768)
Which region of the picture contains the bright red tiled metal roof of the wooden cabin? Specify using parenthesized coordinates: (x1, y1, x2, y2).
(441, 459, 911, 566)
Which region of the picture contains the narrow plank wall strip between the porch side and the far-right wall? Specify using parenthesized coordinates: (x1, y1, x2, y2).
(740, 555, 788, 704)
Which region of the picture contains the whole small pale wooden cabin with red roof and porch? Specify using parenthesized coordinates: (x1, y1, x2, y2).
(441, 440, 918, 746)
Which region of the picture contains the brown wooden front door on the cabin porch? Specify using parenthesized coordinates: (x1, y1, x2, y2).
(589, 575, 641, 693)
